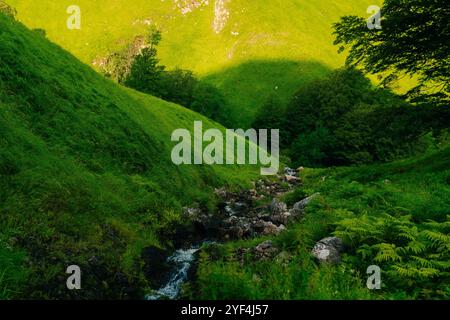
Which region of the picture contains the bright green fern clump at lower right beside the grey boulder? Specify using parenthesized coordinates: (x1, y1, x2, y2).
(335, 214, 450, 299)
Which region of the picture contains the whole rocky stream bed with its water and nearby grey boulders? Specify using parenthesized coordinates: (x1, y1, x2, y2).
(144, 168, 343, 300)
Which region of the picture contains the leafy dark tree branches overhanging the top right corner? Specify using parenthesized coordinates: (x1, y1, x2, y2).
(334, 0, 450, 107)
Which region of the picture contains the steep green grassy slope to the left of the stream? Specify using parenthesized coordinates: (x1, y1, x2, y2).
(0, 14, 258, 298)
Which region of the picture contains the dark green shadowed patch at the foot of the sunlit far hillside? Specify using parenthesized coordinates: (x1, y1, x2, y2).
(202, 60, 331, 127)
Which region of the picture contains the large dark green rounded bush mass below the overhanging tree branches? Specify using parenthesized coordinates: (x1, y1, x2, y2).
(284, 69, 427, 167)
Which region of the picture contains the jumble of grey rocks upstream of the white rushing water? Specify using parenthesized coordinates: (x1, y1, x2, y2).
(184, 174, 315, 240)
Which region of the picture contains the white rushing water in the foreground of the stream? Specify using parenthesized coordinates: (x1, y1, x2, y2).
(146, 247, 199, 300)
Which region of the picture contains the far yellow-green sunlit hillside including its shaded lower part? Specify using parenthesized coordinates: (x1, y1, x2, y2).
(7, 0, 381, 126)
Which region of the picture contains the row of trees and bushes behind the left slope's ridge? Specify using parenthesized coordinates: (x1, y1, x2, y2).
(99, 27, 229, 125)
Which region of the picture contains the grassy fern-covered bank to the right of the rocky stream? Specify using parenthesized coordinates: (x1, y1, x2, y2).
(193, 146, 450, 300)
